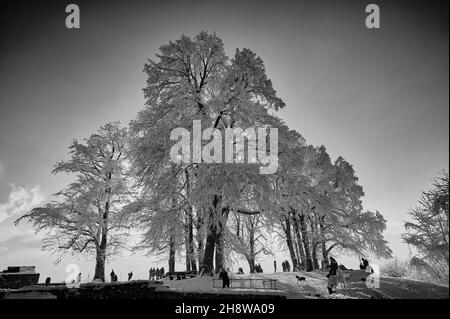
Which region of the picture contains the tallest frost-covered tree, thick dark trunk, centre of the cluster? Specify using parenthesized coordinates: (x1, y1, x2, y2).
(131, 32, 284, 271)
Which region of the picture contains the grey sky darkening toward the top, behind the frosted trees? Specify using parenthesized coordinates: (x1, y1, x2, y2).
(0, 0, 449, 280)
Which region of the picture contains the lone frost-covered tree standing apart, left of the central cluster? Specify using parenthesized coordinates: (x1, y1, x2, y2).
(16, 122, 130, 281)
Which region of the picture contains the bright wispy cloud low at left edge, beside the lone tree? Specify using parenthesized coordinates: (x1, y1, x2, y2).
(0, 185, 44, 224)
